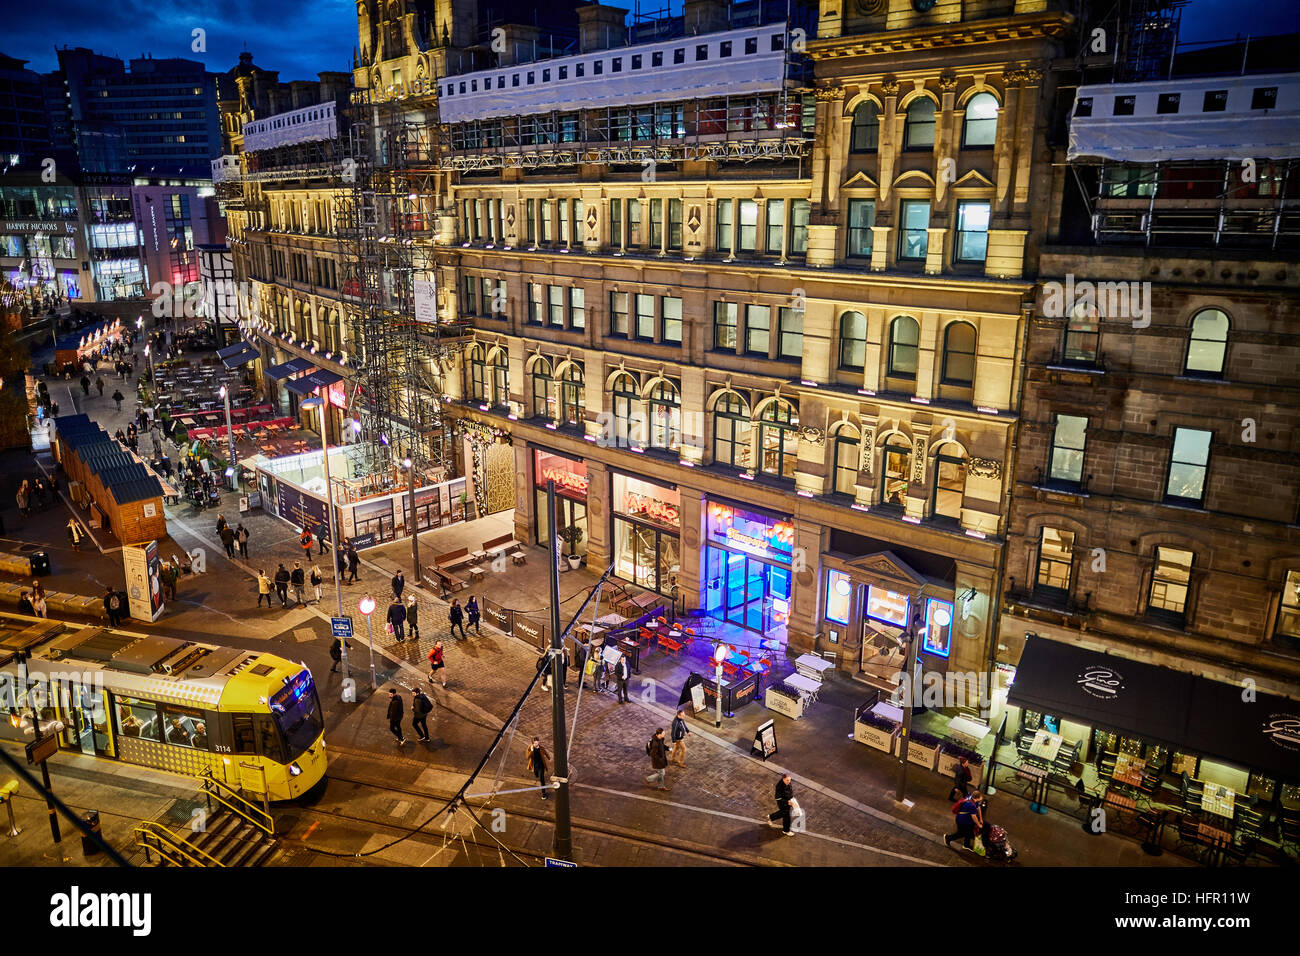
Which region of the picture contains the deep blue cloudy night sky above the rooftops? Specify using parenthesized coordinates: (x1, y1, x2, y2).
(0, 0, 1300, 81)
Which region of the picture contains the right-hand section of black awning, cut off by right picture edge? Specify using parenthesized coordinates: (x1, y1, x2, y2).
(1187, 678, 1300, 782)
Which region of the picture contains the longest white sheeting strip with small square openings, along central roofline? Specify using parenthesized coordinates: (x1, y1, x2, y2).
(438, 23, 788, 122)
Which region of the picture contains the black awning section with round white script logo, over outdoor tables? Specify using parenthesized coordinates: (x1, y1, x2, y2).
(1008, 636, 1197, 749)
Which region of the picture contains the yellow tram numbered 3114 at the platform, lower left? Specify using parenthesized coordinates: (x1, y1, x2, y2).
(0, 613, 325, 800)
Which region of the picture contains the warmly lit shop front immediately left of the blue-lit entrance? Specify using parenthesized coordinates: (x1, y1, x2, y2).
(611, 473, 681, 594)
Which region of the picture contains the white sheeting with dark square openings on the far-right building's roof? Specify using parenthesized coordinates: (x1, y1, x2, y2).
(1067, 74, 1300, 163)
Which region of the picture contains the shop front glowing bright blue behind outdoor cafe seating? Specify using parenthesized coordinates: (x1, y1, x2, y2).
(703, 501, 794, 640)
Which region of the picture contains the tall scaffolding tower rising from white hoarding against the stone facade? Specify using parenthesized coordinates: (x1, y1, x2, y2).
(335, 88, 456, 481)
